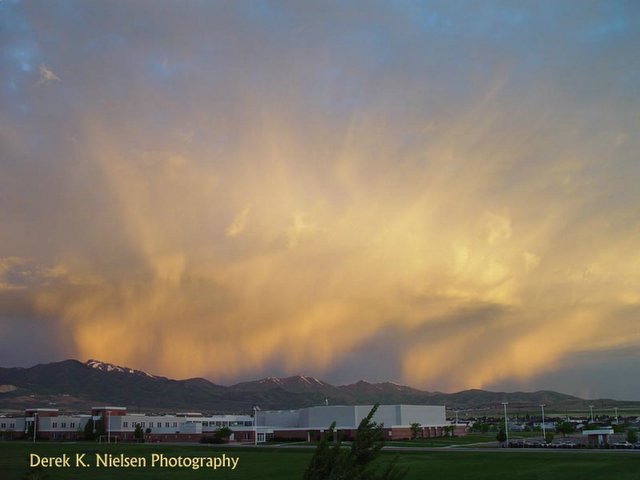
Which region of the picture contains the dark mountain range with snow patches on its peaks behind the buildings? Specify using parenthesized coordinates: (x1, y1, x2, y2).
(0, 360, 637, 413)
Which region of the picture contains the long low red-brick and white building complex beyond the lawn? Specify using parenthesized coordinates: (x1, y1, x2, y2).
(0, 405, 466, 443)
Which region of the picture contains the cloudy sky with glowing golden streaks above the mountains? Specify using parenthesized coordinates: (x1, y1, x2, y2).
(0, 0, 640, 400)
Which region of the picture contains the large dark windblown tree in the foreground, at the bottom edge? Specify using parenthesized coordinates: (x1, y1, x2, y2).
(304, 404, 406, 480)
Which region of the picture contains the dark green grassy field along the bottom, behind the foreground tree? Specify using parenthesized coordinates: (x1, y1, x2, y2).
(0, 442, 640, 480)
